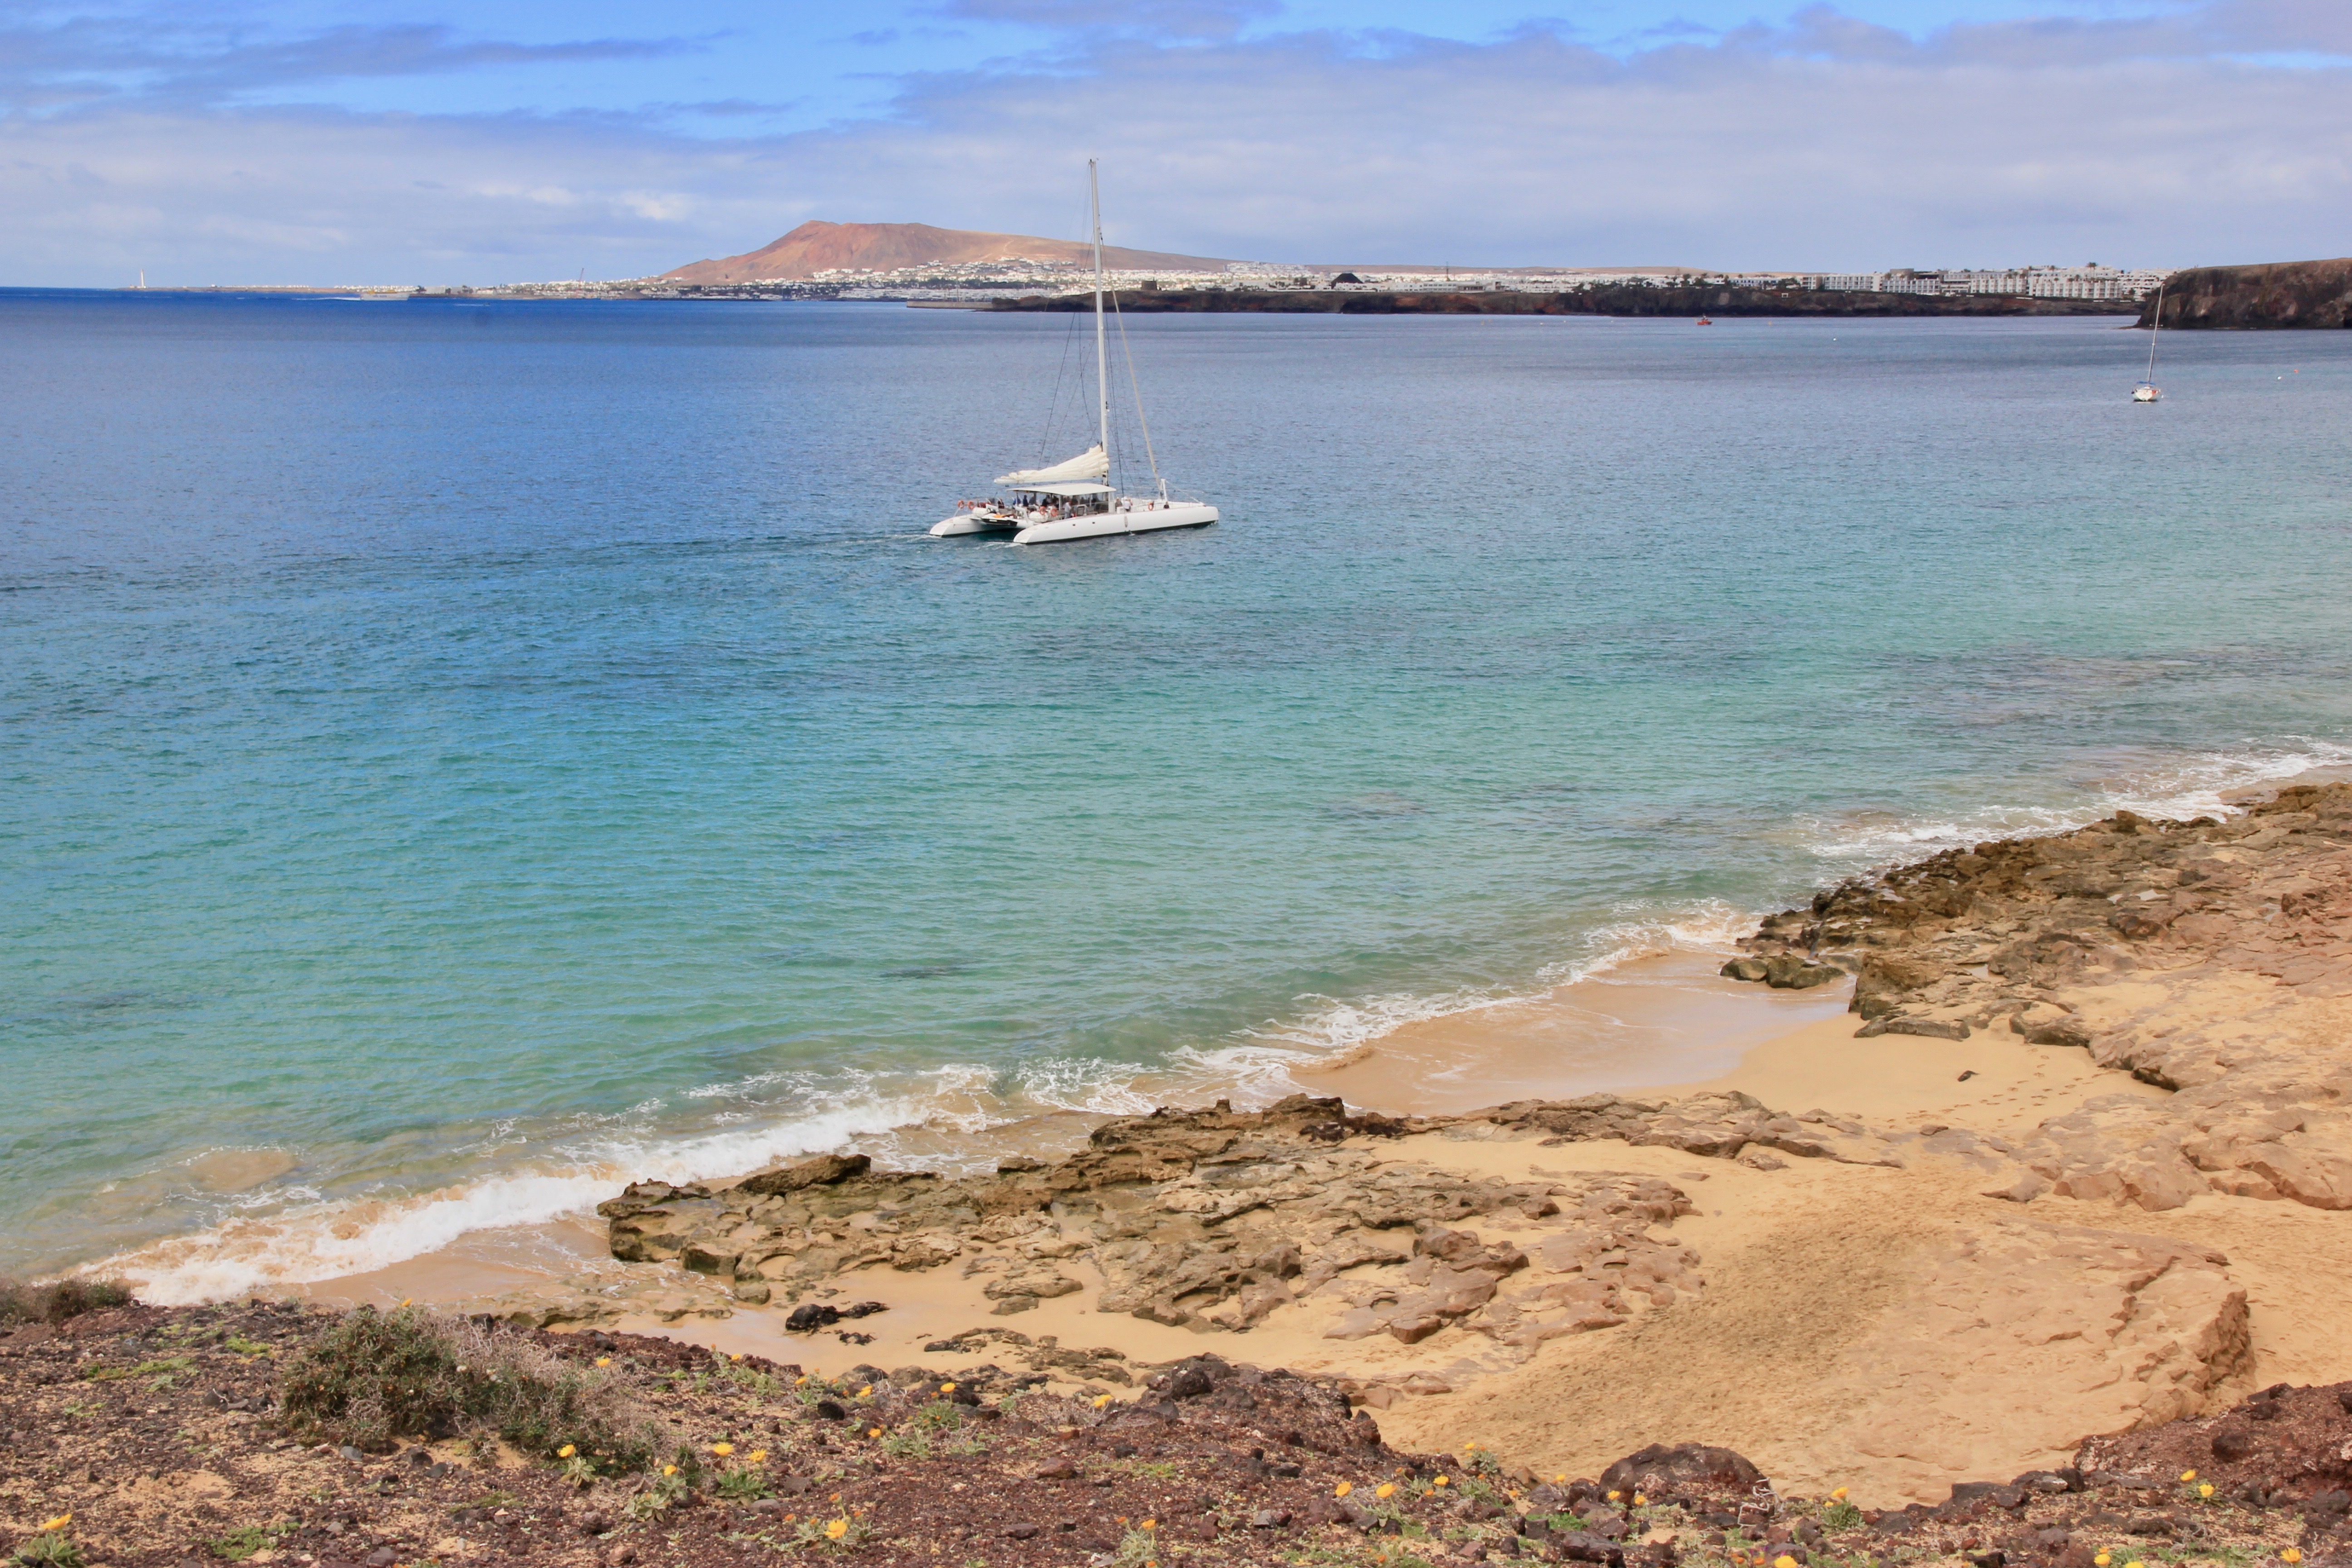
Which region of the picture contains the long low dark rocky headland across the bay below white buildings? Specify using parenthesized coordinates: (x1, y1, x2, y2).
(990, 284, 2131, 317)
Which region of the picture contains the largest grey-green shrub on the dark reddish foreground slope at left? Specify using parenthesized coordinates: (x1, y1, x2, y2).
(280, 1307, 659, 1474)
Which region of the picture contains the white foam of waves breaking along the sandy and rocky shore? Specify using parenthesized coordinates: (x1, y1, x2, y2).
(87, 740, 2352, 1305)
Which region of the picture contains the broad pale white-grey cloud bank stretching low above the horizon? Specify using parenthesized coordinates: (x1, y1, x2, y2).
(0, 0, 2352, 282)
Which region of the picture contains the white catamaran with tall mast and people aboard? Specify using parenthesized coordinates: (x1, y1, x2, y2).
(931, 157, 1216, 545)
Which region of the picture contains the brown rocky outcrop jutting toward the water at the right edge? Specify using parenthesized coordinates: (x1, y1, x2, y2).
(1724, 785, 2352, 1210)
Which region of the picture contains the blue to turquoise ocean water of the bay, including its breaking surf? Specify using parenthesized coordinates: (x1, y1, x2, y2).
(0, 291, 2352, 1295)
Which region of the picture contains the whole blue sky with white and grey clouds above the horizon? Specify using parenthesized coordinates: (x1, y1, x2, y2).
(0, 0, 2352, 287)
